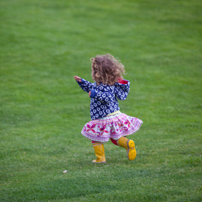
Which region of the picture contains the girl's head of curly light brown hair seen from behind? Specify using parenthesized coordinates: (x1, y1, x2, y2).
(91, 54, 125, 85)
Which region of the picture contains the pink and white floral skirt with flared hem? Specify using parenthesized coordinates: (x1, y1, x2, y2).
(81, 112, 143, 142)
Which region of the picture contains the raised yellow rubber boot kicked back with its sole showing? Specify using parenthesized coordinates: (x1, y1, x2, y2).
(118, 137, 136, 161)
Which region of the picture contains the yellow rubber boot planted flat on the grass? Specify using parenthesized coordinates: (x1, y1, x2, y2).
(92, 142, 106, 163)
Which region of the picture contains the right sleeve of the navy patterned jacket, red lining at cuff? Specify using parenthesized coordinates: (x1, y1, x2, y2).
(114, 80, 130, 100)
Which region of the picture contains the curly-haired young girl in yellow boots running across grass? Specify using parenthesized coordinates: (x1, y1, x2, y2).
(74, 54, 143, 163)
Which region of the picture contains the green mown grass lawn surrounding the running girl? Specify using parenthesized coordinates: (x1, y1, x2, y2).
(0, 0, 202, 202)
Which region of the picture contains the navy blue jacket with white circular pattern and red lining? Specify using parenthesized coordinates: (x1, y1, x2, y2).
(77, 79, 130, 120)
